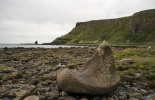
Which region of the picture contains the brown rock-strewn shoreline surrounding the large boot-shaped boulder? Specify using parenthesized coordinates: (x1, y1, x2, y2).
(0, 47, 155, 100)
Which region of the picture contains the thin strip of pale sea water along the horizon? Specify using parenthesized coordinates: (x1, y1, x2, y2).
(0, 44, 86, 48)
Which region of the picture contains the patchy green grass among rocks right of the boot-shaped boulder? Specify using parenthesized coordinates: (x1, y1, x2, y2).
(114, 49, 155, 88)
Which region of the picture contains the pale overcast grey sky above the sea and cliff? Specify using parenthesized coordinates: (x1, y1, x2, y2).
(0, 0, 155, 44)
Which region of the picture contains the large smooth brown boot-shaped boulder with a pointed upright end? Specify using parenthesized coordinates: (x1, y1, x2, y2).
(57, 41, 120, 94)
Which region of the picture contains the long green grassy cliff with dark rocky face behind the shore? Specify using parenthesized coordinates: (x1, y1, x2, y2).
(52, 9, 155, 44)
